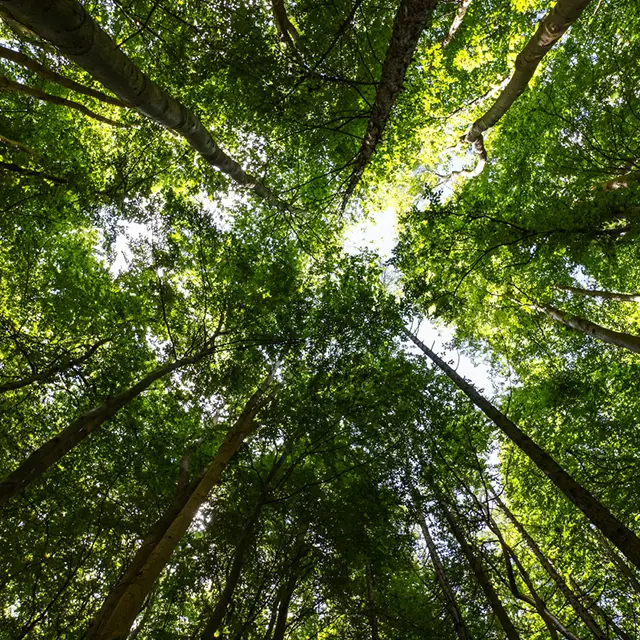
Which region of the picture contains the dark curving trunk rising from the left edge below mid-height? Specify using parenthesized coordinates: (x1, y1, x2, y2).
(0, 347, 214, 505)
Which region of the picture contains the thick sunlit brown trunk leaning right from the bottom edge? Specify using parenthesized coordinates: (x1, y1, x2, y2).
(85, 371, 275, 640)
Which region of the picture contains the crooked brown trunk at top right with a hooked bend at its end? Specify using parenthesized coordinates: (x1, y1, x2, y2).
(464, 0, 590, 175)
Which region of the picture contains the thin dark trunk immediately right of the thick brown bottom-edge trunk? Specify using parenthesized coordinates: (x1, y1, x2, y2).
(202, 451, 286, 640)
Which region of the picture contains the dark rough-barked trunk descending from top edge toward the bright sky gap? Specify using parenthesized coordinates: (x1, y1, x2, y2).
(342, 0, 437, 209)
